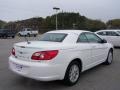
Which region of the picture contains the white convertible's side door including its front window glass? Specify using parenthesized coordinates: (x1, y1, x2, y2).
(85, 32, 108, 66)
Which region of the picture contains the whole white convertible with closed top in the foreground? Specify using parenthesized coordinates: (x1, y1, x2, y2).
(9, 30, 113, 85)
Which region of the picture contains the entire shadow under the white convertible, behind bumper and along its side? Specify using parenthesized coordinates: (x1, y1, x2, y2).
(12, 64, 112, 90)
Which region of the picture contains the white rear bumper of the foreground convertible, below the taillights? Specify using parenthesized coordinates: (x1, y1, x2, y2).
(9, 56, 65, 81)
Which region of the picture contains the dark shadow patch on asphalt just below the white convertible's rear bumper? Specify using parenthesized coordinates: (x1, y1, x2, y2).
(16, 76, 69, 90)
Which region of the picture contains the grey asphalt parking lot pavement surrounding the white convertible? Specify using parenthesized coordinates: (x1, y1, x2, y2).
(0, 37, 120, 90)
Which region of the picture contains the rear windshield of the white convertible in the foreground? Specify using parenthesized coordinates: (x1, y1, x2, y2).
(39, 33, 67, 42)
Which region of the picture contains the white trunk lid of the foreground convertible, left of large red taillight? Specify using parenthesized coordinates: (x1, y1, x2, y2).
(14, 41, 61, 61)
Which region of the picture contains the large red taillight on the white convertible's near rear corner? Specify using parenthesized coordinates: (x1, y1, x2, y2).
(31, 50, 58, 60)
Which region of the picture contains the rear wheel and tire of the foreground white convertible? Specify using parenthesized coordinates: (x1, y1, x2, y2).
(63, 61, 81, 86)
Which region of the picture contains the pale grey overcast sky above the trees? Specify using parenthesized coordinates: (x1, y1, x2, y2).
(0, 0, 120, 21)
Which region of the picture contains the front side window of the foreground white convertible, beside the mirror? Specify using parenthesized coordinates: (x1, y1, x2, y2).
(85, 33, 101, 43)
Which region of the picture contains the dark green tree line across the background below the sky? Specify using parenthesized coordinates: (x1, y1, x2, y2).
(0, 12, 120, 33)
